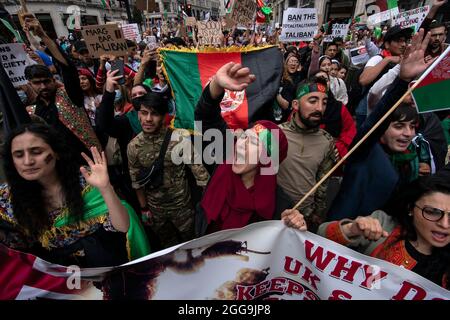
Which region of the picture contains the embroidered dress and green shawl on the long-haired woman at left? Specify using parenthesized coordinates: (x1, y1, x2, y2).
(0, 177, 150, 260)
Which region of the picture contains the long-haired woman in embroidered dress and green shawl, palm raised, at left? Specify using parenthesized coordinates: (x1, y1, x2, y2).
(0, 123, 149, 267)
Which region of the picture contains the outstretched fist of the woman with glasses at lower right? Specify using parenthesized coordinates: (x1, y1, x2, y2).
(343, 217, 389, 241)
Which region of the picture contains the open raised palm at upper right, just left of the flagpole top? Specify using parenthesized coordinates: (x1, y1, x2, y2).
(400, 29, 436, 81)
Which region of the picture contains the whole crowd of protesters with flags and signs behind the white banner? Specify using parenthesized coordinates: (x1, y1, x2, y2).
(0, 0, 450, 298)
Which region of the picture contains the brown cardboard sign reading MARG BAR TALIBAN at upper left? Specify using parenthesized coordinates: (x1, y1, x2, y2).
(81, 24, 128, 58)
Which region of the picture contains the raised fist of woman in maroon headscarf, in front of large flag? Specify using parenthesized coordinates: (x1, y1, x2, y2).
(210, 62, 256, 97)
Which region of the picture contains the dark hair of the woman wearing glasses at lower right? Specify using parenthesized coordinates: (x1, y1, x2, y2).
(386, 171, 450, 289)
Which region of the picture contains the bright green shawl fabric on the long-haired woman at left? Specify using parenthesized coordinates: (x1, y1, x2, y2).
(54, 187, 150, 260)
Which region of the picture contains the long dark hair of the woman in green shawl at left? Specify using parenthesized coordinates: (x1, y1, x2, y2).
(3, 123, 83, 238)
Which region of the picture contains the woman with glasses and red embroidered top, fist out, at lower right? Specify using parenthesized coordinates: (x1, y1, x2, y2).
(318, 174, 450, 289)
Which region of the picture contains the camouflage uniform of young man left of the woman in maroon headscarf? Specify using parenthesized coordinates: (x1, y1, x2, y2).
(127, 128, 209, 247)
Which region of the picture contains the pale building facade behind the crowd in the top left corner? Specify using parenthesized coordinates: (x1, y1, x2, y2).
(5, 0, 128, 38)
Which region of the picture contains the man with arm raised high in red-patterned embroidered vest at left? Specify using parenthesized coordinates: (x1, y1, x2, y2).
(24, 14, 101, 164)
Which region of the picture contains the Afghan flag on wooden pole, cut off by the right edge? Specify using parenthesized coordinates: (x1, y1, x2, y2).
(412, 47, 450, 113)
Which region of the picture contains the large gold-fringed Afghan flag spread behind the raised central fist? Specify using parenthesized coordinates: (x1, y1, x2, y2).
(160, 46, 283, 130)
